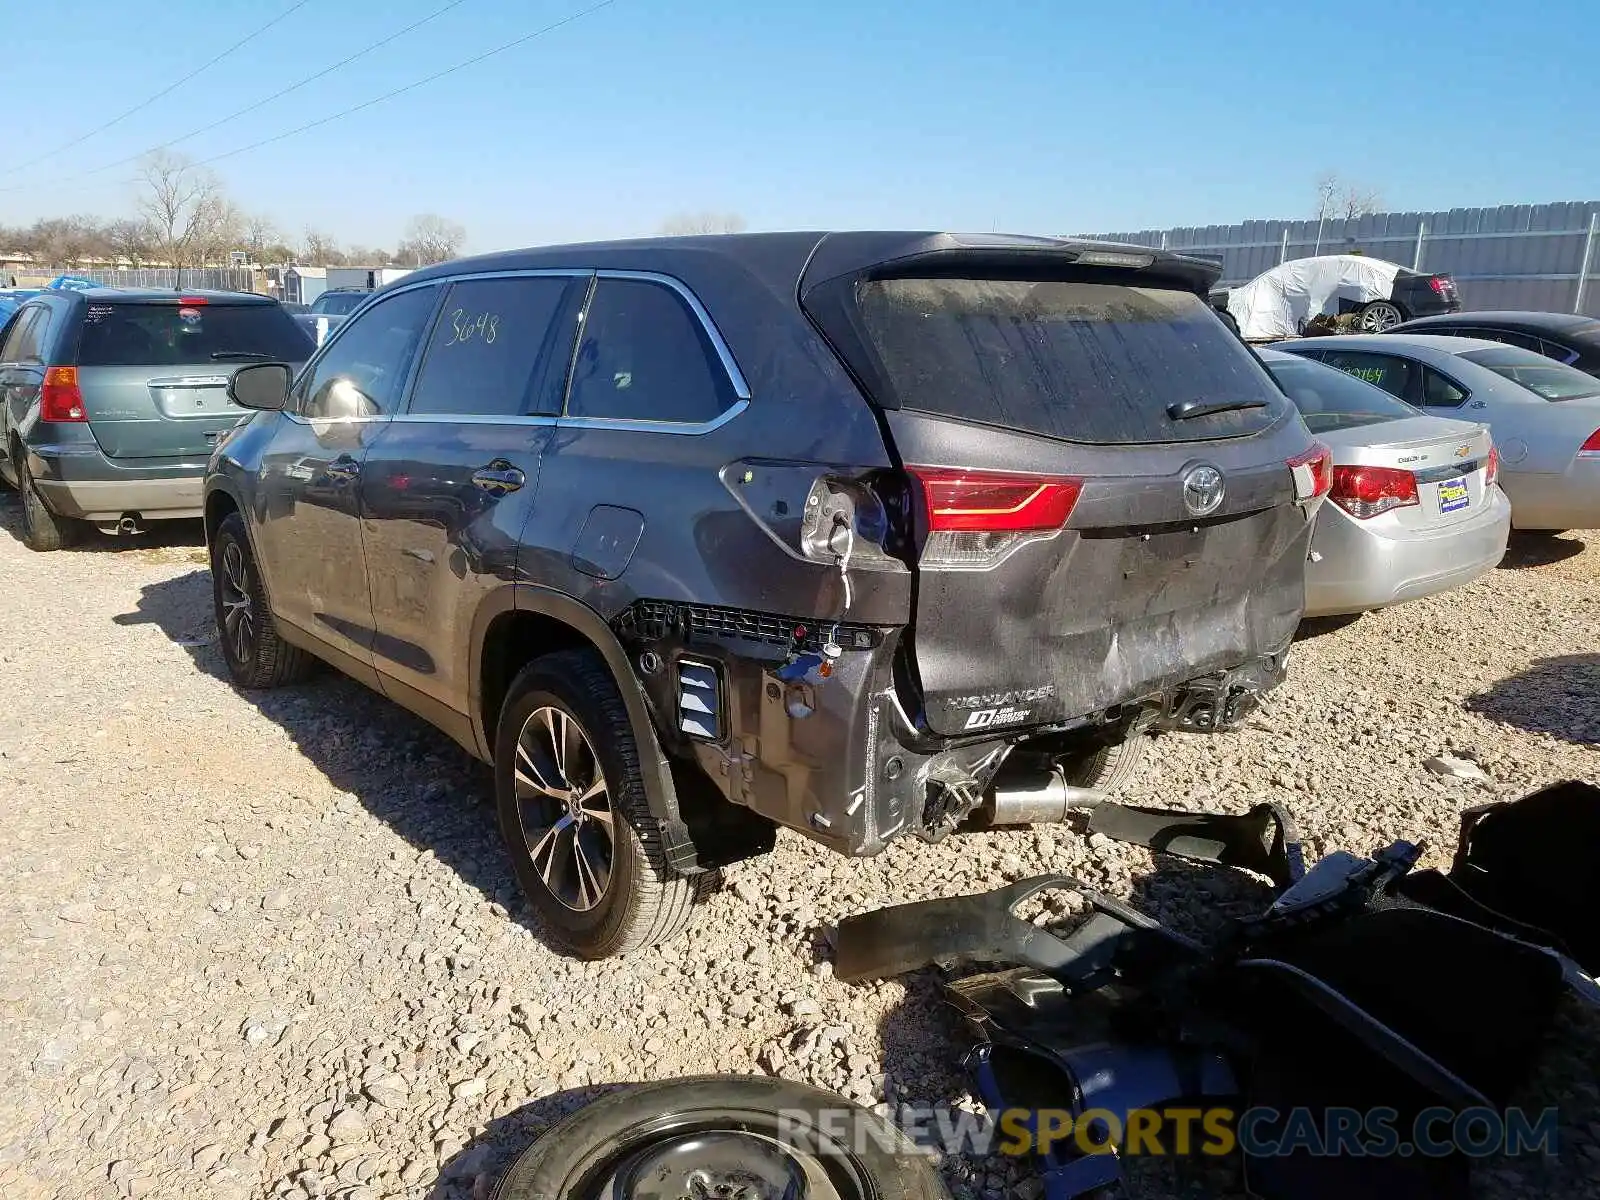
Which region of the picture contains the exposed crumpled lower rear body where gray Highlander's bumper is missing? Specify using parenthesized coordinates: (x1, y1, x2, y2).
(619, 604, 1286, 856)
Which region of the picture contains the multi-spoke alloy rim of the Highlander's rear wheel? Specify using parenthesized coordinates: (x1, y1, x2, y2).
(512, 706, 616, 912)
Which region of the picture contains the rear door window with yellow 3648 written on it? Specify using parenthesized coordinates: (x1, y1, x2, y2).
(410, 278, 571, 416)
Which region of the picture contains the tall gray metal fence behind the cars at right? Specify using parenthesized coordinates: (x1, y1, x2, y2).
(1088, 200, 1600, 317)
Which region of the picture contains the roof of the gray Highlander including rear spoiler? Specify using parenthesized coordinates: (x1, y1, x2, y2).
(402, 230, 1219, 291)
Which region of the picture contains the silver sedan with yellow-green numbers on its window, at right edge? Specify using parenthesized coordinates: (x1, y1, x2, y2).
(1274, 333, 1600, 530)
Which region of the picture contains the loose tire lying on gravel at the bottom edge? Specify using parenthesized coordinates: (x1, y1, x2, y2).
(493, 1075, 949, 1200)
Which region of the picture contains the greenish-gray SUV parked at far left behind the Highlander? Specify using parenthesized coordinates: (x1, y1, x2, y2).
(0, 288, 312, 550)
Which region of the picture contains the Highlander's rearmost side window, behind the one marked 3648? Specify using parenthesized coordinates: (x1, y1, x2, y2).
(566, 278, 736, 424)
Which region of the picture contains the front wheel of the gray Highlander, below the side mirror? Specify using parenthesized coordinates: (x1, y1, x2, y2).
(211, 512, 317, 688)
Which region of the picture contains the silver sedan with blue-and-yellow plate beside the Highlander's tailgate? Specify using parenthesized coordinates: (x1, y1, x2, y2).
(1261, 338, 1510, 616)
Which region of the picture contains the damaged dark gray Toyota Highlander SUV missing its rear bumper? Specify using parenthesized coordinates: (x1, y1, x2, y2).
(205, 234, 1330, 957)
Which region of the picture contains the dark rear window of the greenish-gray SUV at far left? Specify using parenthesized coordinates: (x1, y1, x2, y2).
(78, 304, 312, 366)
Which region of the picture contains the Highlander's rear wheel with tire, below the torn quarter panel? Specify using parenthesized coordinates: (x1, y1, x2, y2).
(494, 650, 704, 958)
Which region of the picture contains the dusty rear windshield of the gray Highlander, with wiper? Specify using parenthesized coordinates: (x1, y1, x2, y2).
(858, 278, 1285, 443)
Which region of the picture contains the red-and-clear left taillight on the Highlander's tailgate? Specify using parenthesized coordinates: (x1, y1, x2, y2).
(907, 467, 1083, 570)
